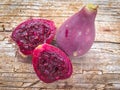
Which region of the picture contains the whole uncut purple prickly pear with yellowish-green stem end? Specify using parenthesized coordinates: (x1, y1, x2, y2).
(56, 4, 98, 57)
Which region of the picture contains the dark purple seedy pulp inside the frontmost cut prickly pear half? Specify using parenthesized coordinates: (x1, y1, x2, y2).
(38, 51, 68, 81)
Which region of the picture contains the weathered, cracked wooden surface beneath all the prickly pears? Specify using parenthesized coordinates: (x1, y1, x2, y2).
(0, 0, 120, 90)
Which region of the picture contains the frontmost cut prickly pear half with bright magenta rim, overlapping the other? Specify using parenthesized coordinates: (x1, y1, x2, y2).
(32, 43, 72, 83)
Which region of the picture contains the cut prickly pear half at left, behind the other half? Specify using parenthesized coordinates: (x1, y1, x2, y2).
(11, 19, 56, 55)
